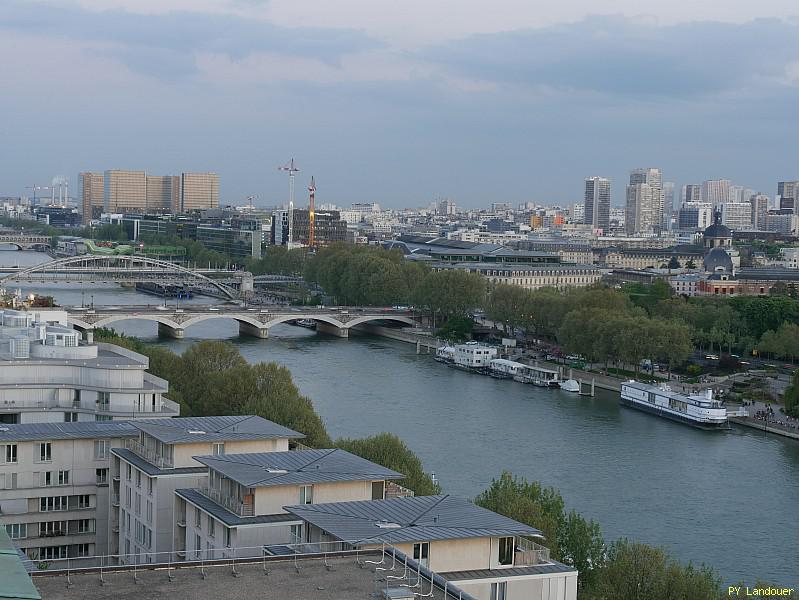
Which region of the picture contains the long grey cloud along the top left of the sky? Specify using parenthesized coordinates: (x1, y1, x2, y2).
(0, 0, 379, 76)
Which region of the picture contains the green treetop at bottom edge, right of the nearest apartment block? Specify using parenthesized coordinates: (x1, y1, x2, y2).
(581, 539, 726, 600)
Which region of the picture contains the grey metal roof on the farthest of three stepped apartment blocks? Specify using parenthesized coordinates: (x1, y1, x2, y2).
(133, 415, 305, 444)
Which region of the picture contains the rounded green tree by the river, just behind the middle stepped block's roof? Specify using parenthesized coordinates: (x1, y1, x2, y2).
(336, 433, 441, 496)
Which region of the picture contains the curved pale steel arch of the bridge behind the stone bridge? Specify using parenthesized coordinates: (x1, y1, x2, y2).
(0, 253, 238, 299)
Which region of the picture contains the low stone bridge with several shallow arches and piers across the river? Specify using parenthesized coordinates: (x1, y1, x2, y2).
(65, 305, 417, 339)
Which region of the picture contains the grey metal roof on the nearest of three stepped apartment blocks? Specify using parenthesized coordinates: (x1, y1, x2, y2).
(284, 494, 541, 544)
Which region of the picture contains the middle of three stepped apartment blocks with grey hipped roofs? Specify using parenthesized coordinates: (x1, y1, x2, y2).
(175, 449, 404, 560)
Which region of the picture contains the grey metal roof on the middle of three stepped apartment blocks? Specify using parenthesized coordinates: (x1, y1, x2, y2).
(194, 448, 404, 487)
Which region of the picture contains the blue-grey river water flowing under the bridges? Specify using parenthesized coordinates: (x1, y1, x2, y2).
(7, 252, 799, 587)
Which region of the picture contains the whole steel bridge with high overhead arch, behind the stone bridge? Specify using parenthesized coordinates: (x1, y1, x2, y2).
(0, 254, 252, 300)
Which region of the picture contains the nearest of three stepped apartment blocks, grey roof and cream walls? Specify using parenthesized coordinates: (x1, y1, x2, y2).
(286, 495, 577, 600)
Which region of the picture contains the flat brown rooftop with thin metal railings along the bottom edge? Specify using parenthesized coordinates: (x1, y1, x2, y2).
(33, 555, 467, 600)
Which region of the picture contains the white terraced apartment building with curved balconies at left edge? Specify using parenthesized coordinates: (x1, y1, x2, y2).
(0, 310, 180, 423)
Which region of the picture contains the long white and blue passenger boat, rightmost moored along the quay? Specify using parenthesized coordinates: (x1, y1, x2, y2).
(621, 380, 730, 430)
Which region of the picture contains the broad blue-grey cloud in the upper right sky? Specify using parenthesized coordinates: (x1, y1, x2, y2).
(422, 16, 799, 97)
